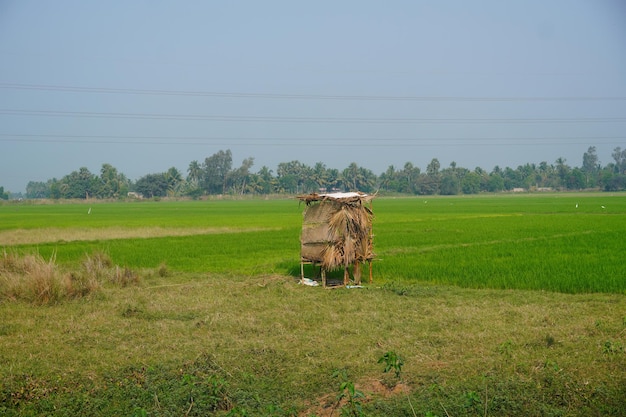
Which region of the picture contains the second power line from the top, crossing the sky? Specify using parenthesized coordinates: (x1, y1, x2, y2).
(0, 109, 626, 124)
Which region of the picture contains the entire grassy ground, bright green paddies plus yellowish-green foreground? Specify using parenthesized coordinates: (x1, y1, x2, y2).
(0, 194, 626, 417)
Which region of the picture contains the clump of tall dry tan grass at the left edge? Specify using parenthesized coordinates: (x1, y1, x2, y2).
(0, 250, 140, 305)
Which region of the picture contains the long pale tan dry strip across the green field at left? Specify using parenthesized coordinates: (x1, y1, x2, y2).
(0, 227, 278, 246)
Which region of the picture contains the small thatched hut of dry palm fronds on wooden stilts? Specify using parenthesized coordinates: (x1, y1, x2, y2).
(298, 192, 374, 286)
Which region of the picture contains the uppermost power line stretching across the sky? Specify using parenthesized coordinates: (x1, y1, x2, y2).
(0, 83, 626, 102)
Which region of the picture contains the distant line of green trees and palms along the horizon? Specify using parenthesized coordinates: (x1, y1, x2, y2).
(19, 146, 626, 199)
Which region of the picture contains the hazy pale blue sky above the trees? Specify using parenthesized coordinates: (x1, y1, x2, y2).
(0, 0, 626, 192)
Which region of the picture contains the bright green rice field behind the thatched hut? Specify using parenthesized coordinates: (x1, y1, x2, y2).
(0, 194, 626, 293)
